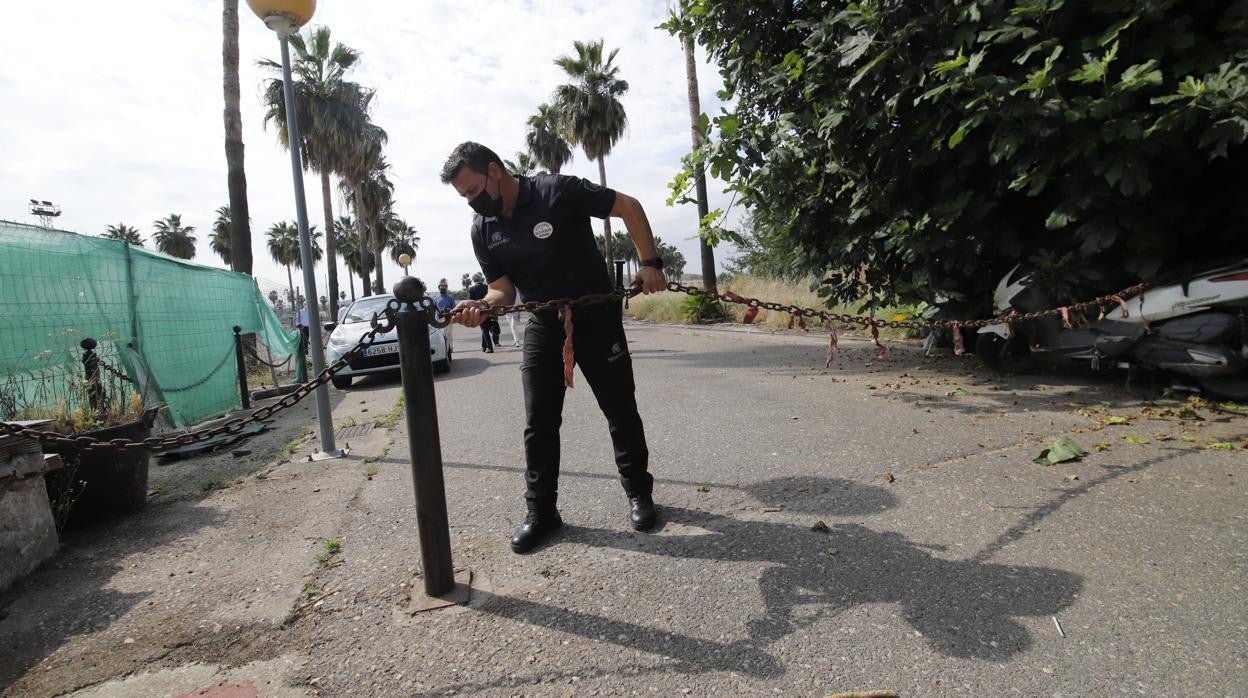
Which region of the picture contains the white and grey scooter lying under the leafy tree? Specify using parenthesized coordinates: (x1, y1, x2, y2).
(975, 260, 1248, 401)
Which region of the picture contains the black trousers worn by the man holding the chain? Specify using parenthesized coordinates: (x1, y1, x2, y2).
(520, 303, 654, 503)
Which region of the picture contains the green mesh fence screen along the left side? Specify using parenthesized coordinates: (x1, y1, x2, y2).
(0, 221, 298, 426)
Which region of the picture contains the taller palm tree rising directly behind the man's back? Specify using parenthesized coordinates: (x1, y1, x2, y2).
(554, 39, 628, 268)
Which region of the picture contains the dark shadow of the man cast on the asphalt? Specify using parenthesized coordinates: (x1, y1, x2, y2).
(563, 477, 1082, 661)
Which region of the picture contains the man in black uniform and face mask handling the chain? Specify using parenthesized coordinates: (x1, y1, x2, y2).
(442, 141, 666, 553)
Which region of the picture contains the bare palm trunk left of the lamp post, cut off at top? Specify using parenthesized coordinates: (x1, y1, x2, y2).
(221, 0, 251, 275)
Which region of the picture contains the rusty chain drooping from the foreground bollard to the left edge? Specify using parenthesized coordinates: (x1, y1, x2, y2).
(0, 300, 399, 451)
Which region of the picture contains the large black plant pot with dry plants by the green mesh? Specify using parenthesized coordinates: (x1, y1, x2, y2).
(45, 407, 157, 526)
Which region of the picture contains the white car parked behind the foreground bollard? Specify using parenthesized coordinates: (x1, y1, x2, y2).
(326, 293, 454, 390)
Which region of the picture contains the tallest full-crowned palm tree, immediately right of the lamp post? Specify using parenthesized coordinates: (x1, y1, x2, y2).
(260, 26, 372, 317)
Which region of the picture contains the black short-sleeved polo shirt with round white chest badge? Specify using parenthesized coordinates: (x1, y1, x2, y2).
(472, 175, 615, 301)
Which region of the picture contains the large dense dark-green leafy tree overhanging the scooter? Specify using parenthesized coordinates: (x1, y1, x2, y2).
(668, 0, 1248, 315)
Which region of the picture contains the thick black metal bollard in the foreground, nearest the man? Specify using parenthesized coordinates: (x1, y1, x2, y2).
(393, 276, 456, 597)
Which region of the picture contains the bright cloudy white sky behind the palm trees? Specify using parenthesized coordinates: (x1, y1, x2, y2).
(0, 0, 736, 303)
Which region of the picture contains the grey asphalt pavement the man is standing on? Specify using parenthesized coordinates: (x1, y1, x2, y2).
(0, 323, 1248, 697)
